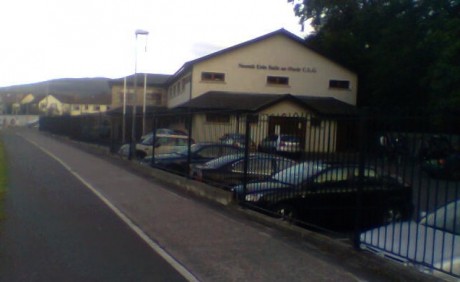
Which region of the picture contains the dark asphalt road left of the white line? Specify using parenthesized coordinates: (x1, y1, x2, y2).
(0, 132, 185, 281)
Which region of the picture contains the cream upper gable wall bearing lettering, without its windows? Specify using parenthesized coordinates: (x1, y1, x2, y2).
(168, 35, 358, 107)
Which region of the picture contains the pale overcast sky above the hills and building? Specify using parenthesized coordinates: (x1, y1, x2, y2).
(0, 0, 308, 87)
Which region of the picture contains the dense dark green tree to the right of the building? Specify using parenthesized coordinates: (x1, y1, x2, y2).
(288, 0, 460, 117)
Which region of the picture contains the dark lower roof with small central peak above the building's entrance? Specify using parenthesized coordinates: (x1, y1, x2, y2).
(177, 91, 357, 116)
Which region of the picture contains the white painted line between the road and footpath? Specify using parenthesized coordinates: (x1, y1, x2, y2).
(22, 136, 199, 282)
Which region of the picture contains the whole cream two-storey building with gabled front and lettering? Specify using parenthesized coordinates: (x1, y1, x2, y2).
(108, 29, 358, 150)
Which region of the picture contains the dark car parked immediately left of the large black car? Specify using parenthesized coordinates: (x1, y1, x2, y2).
(190, 153, 295, 189)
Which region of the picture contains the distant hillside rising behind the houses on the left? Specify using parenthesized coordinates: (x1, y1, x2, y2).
(0, 78, 110, 97)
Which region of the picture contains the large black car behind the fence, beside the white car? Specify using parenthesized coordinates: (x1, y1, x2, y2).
(234, 162, 412, 230)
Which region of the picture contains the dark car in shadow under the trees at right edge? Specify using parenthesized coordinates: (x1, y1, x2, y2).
(422, 152, 460, 180)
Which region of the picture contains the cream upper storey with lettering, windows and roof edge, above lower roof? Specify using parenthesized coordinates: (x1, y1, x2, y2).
(167, 29, 358, 108)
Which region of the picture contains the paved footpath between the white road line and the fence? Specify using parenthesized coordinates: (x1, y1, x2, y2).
(17, 129, 434, 281)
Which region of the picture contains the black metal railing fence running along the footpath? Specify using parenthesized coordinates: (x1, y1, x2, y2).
(40, 111, 460, 277)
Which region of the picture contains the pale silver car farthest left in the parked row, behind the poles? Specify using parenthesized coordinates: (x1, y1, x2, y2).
(118, 134, 195, 159)
